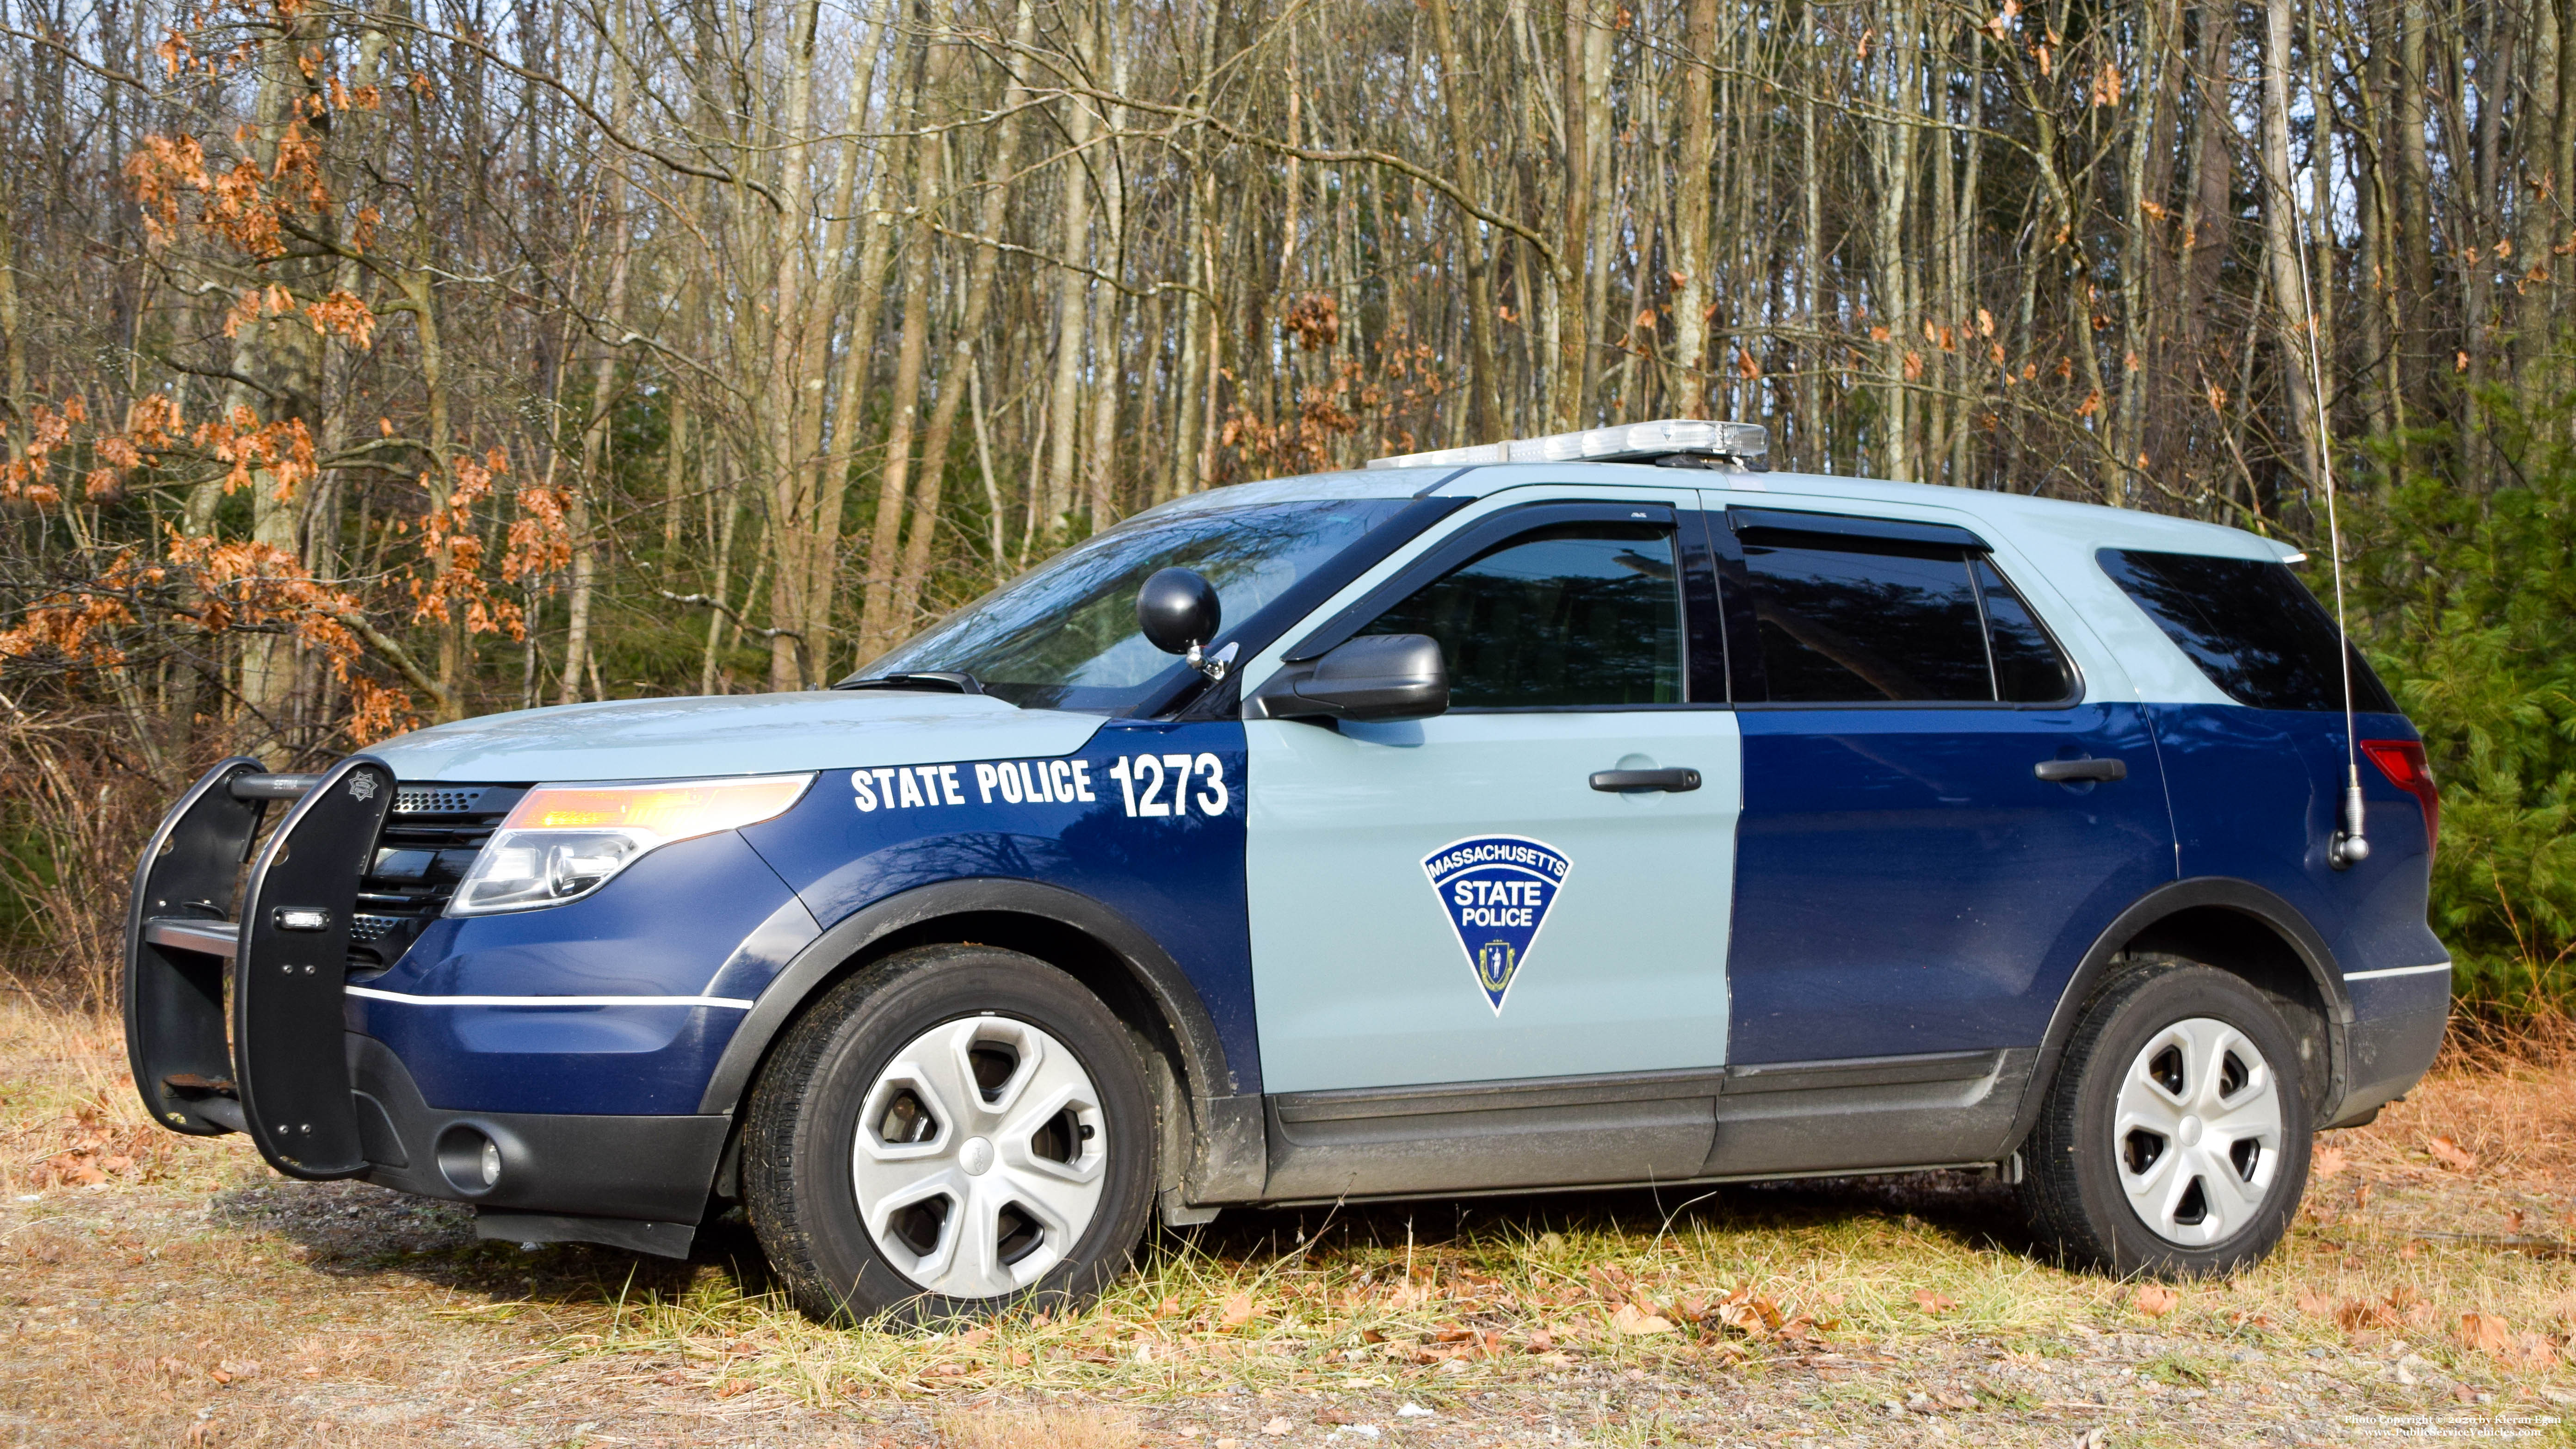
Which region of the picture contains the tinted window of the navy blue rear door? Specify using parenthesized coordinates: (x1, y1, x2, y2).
(1744, 531, 2074, 704)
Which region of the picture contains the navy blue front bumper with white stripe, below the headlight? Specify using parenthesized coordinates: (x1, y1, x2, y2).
(348, 833, 811, 1116)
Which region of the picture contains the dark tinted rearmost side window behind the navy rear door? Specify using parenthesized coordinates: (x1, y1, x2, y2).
(2094, 549, 2398, 714)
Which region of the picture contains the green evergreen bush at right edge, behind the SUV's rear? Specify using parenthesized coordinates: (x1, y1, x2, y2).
(2360, 392, 2576, 1016)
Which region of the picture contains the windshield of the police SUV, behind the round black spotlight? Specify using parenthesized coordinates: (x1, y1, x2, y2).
(852, 498, 1404, 714)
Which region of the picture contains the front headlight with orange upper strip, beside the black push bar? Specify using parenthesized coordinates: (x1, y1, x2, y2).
(448, 774, 814, 915)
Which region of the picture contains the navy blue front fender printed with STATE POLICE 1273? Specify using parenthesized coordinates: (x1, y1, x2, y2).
(742, 719, 1260, 1093)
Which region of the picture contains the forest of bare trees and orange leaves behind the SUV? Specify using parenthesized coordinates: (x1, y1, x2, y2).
(0, 0, 2576, 1029)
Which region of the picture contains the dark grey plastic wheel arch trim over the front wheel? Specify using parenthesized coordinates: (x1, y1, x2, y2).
(698, 877, 1270, 1201)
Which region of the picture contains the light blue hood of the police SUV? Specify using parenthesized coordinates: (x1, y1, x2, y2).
(366, 688, 1100, 784)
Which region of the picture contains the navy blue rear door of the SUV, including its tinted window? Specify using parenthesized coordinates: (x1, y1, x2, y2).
(1708, 508, 2174, 1065)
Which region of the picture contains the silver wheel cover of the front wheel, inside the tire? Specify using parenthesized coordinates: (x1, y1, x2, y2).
(850, 1016, 1108, 1300)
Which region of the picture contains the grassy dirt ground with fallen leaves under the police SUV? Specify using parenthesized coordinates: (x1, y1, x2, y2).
(0, 1008, 2576, 1449)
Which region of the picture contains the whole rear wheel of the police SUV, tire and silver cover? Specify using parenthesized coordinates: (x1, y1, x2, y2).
(2022, 957, 2310, 1279)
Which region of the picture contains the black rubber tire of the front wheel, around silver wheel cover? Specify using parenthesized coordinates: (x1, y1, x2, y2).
(742, 946, 1156, 1325)
